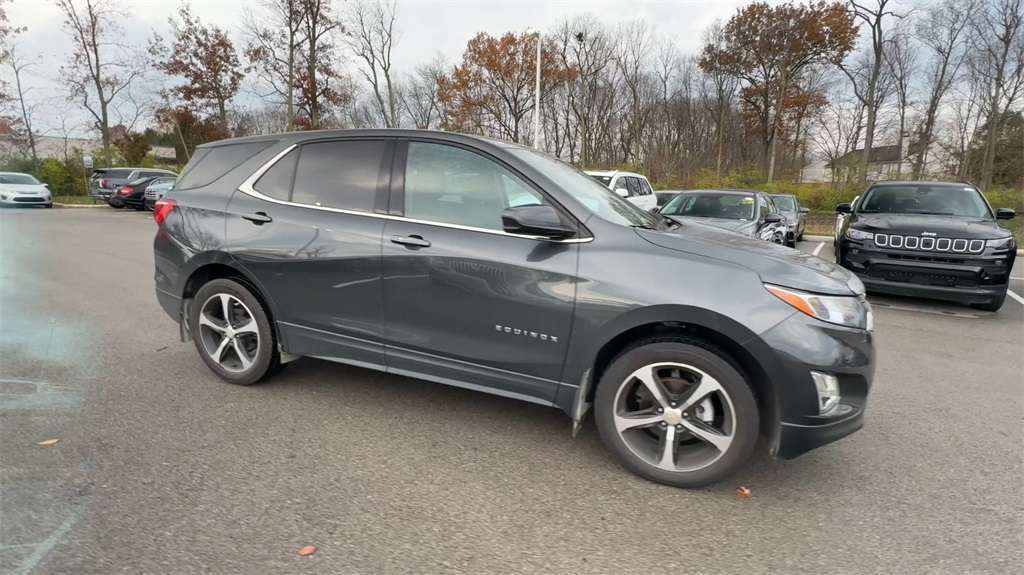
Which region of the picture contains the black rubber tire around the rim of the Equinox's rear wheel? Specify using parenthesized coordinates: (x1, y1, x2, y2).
(188, 278, 282, 386)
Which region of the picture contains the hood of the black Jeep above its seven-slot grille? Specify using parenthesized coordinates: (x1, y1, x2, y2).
(850, 214, 1010, 239)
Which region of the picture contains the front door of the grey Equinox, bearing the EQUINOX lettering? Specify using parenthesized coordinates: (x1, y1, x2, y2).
(383, 139, 580, 403)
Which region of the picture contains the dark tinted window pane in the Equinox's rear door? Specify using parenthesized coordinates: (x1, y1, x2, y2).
(292, 140, 387, 212)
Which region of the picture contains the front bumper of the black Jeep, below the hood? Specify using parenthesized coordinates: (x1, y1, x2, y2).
(839, 237, 1017, 304)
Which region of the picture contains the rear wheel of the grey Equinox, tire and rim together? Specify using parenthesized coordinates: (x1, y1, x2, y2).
(189, 279, 282, 386)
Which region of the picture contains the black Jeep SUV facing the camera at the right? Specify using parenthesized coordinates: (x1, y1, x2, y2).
(836, 181, 1017, 311)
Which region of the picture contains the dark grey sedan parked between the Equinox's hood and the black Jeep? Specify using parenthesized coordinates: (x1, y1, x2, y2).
(657, 189, 786, 245)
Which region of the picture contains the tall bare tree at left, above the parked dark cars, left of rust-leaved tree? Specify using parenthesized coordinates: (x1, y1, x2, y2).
(56, 0, 148, 166)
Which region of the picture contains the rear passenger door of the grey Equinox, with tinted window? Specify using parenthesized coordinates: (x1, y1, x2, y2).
(226, 138, 394, 368)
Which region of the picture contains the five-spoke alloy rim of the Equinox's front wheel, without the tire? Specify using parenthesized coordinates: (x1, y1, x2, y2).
(613, 362, 736, 472)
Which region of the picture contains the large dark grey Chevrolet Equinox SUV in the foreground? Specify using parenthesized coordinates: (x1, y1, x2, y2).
(154, 130, 876, 487)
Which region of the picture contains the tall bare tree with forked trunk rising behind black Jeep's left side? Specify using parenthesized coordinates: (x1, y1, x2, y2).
(840, 0, 904, 185)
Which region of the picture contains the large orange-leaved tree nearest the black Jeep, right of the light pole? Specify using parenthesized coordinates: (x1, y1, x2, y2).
(700, 1, 857, 183)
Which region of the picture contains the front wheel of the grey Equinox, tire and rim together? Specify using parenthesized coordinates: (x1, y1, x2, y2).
(594, 337, 759, 488)
